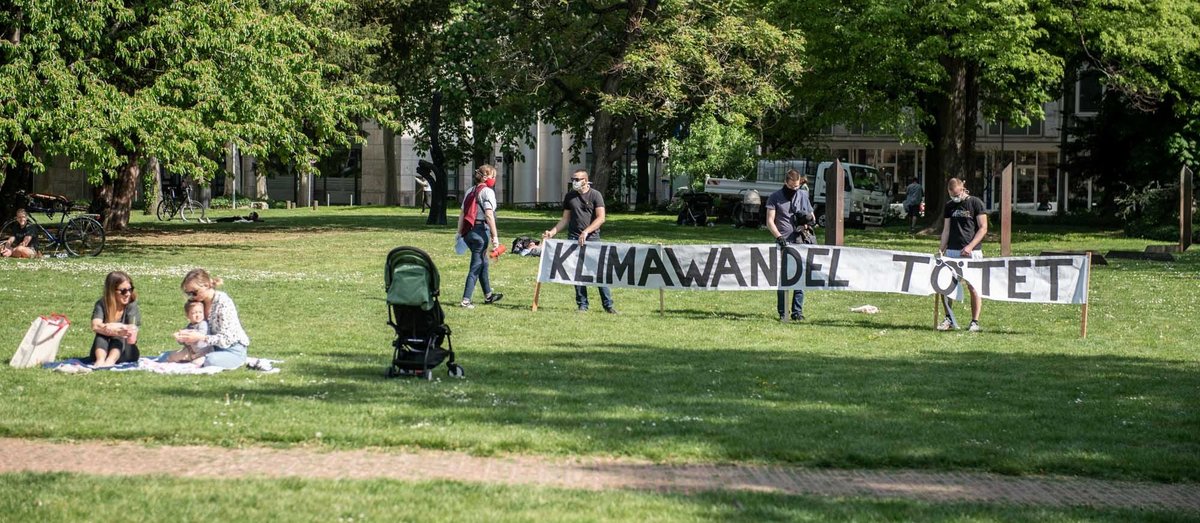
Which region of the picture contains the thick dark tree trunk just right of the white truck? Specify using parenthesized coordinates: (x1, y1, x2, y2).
(925, 58, 983, 230)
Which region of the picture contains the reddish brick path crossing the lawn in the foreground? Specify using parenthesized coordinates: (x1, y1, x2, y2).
(0, 438, 1200, 511)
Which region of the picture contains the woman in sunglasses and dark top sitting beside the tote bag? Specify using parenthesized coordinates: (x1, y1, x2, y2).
(84, 271, 142, 367)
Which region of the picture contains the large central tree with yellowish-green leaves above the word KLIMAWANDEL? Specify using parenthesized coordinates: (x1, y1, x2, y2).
(506, 0, 803, 193)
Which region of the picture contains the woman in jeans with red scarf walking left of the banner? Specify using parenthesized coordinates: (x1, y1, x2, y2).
(458, 164, 504, 308)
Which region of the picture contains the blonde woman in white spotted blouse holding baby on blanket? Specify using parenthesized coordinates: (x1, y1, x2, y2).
(175, 269, 250, 368)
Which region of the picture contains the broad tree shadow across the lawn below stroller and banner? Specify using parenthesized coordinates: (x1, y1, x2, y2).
(145, 342, 1200, 481)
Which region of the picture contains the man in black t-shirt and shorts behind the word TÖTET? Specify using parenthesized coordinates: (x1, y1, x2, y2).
(937, 178, 988, 332)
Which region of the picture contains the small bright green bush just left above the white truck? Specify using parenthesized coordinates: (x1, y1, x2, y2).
(670, 115, 757, 188)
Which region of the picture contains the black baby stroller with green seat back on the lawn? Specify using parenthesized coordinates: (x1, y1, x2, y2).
(383, 247, 464, 379)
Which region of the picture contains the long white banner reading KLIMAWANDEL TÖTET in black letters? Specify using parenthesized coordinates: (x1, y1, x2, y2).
(538, 240, 1088, 303)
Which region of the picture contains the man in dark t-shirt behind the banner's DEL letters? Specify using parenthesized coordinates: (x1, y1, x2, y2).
(767, 169, 816, 321)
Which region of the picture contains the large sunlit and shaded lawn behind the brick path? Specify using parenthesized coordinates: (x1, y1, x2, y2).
(0, 208, 1200, 482)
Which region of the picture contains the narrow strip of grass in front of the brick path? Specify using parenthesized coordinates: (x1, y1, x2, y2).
(0, 474, 1189, 523)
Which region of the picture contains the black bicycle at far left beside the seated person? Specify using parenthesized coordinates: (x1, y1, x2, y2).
(0, 191, 104, 258)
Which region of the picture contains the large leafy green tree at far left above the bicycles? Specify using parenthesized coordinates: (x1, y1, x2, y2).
(0, 0, 383, 229)
